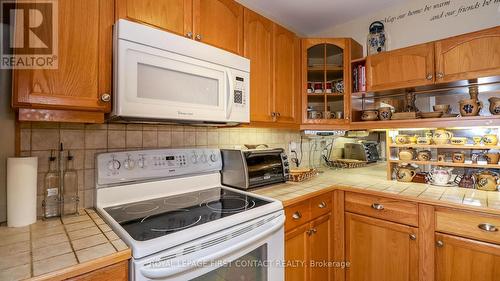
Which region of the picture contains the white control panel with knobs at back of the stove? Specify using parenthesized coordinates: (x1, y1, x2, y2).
(96, 149, 222, 187)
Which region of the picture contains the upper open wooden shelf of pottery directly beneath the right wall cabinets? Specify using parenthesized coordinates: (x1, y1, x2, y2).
(351, 77, 500, 129)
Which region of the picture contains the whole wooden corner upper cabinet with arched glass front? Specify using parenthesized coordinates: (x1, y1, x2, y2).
(302, 38, 359, 127)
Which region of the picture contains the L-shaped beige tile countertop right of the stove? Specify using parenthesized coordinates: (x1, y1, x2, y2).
(252, 164, 500, 214)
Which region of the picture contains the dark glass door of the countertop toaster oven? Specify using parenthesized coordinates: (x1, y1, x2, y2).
(243, 149, 286, 188)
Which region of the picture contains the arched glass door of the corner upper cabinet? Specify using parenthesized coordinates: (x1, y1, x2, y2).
(305, 40, 345, 123)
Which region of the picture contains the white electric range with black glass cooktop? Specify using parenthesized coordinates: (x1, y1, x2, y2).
(96, 149, 285, 281)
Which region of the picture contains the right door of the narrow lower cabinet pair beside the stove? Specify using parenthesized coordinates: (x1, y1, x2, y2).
(309, 214, 333, 281)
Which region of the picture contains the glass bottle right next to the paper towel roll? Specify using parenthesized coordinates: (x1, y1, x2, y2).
(42, 152, 61, 219)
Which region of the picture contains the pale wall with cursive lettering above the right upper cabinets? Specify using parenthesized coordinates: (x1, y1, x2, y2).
(310, 0, 500, 53)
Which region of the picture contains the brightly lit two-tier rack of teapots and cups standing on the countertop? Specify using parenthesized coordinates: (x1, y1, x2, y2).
(386, 126, 500, 191)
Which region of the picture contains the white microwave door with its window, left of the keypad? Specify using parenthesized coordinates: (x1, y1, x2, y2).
(112, 39, 236, 122)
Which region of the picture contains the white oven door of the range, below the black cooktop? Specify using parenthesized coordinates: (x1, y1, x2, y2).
(135, 211, 285, 281)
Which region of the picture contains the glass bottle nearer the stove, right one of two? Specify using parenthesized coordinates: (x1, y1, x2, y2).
(62, 151, 80, 216)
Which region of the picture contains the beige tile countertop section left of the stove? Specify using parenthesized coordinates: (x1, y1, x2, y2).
(0, 209, 131, 280)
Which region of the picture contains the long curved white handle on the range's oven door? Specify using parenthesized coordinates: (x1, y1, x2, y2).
(140, 216, 285, 279)
